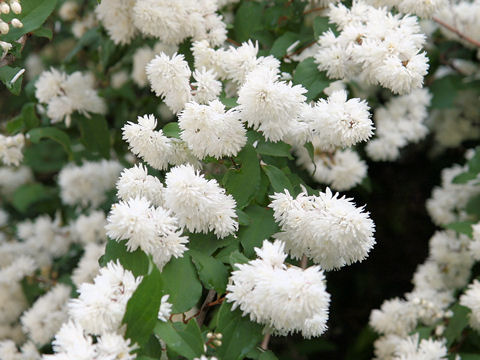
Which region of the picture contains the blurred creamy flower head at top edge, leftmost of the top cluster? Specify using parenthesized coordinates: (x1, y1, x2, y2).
(95, 0, 136, 45)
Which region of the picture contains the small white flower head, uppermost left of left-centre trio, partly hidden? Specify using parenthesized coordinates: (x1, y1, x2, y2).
(117, 164, 163, 206)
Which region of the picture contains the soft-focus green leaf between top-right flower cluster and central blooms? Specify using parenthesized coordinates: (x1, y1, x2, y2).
(293, 57, 330, 101)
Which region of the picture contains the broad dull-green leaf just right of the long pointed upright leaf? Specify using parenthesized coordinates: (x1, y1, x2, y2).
(161, 253, 202, 313)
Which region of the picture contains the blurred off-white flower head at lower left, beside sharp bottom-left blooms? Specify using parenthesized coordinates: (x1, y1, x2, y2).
(20, 284, 71, 346)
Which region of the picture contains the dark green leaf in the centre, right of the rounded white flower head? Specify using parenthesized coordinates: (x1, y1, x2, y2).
(223, 145, 260, 209)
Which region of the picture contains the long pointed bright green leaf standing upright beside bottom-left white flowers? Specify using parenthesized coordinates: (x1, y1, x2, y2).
(122, 264, 164, 346)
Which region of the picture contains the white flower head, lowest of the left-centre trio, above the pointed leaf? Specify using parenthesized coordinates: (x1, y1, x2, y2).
(106, 197, 188, 268)
